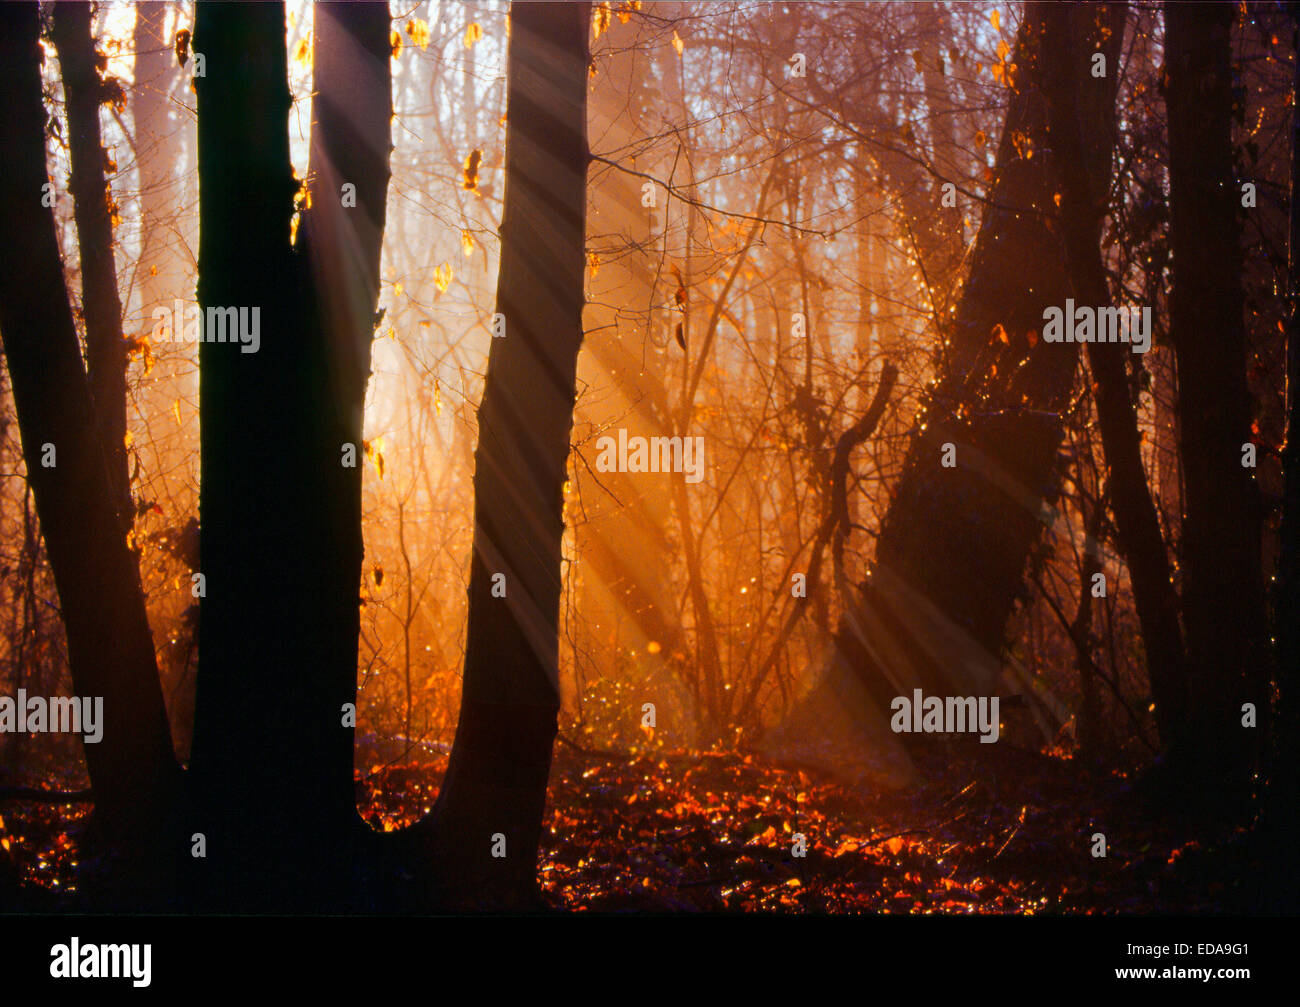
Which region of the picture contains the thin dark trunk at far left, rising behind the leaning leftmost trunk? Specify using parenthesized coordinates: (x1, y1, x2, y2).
(51, 3, 131, 525)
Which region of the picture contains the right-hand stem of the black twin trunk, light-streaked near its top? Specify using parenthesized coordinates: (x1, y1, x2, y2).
(298, 0, 393, 867)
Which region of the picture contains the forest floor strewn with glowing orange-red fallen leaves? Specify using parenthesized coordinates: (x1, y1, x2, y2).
(0, 743, 1269, 915)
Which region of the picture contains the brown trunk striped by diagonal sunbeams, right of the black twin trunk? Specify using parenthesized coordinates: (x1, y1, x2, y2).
(411, 3, 590, 906)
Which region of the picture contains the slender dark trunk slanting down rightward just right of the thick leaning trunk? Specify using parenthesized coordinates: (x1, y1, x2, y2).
(1052, 8, 1187, 745)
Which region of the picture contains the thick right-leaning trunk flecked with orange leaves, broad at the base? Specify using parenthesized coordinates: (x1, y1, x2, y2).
(836, 3, 1123, 709)
